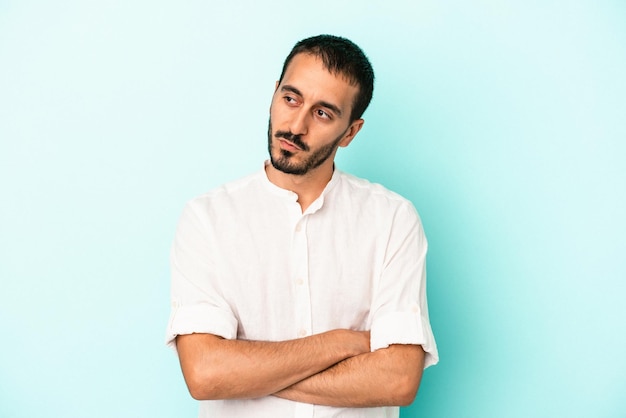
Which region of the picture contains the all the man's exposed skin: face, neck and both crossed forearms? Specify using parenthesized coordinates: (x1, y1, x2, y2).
(177, 54, 424, 407)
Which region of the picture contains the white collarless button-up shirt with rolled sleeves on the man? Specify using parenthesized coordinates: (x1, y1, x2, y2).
(167, 165, 438, 418)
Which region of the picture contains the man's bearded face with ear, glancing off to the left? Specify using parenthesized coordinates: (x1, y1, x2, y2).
(268, 54, 363, 175)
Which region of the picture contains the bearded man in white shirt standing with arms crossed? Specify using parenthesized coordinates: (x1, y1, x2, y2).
(168, 35, 438, 418)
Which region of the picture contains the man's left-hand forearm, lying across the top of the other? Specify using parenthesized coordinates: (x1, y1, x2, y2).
(177, 330, 369, 399)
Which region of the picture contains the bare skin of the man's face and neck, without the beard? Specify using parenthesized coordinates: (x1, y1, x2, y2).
(266, 54, 364, 212)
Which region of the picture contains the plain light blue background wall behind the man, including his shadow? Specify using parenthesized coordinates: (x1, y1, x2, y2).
(0, 0, 626, 418)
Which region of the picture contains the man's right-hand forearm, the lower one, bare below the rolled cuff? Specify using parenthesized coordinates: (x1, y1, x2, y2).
(275, 345, 424, 407)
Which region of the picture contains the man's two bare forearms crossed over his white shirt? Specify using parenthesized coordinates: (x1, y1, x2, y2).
(176, 330, 424, 407)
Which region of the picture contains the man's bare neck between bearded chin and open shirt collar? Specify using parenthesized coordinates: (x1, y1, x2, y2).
(265, 159, 334, 213)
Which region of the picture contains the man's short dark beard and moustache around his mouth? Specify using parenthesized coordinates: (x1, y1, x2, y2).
(267, 120, 345, 176)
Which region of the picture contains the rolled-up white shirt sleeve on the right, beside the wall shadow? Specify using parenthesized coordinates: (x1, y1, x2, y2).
(370, 202, 439, 367)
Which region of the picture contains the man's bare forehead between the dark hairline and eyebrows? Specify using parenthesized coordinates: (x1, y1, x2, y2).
(280, 53, 358, 114)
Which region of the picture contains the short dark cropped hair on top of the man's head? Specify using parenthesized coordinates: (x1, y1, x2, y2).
(278, 35, 374, 122)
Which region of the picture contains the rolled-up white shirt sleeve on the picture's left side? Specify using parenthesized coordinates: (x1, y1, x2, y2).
(166, 201, 238, 350)
